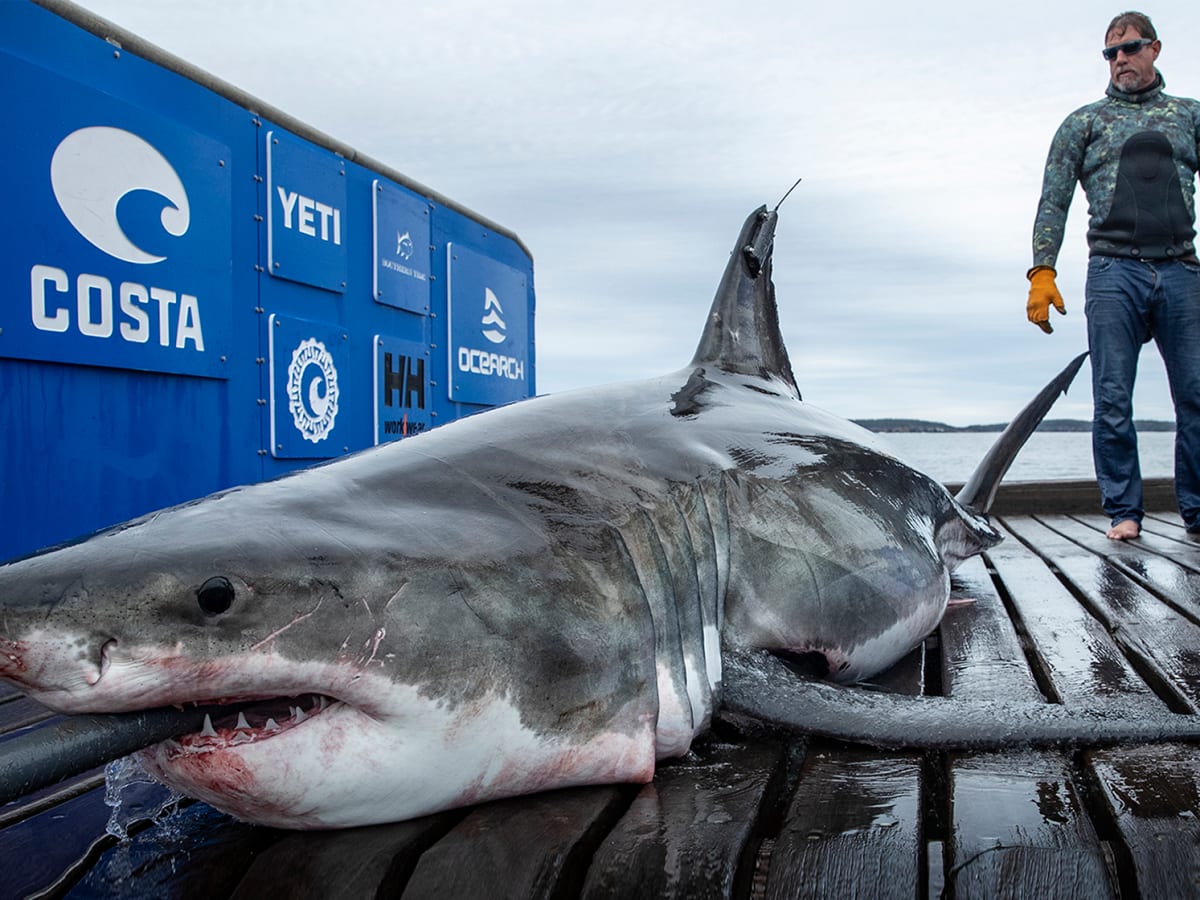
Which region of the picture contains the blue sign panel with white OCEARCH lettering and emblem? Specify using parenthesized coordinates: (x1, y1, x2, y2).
(446, 244, 529, 406)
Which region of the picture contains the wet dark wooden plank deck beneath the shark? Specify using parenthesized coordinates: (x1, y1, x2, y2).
(0, 492, 1200, 899)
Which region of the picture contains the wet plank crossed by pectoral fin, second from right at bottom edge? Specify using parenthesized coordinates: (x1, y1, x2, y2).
(942, 544, 1114, 898)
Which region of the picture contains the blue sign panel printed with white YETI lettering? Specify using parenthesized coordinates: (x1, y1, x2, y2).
(266, 130, 348, 293)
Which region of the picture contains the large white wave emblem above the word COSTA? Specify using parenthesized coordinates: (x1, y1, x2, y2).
(50, 125, 191, 264)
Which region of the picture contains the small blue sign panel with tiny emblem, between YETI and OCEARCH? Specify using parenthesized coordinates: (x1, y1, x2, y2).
(371, 179, 430, 316)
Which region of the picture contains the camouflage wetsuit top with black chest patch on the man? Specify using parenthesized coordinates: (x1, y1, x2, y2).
(1033, 74, 1200, 268)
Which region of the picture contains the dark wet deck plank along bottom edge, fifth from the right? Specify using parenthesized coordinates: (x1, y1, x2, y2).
(403, 786, 629, 900)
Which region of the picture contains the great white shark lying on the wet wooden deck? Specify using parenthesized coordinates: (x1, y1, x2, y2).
(0, 208, 1196, 828)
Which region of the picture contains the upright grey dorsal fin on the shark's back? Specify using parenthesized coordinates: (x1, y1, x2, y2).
(692, 206, 799, 397)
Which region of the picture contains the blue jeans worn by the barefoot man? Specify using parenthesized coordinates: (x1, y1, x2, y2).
(1085, 257, 1200, 529)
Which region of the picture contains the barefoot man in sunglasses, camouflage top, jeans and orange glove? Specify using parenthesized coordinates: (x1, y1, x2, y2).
(1026, 12, 1200, 540)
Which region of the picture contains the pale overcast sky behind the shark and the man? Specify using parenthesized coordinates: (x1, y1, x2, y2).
(75, 0, 1200, 425)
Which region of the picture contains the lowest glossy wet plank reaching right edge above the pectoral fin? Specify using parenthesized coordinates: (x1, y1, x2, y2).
(1009, 520, 1200, 712)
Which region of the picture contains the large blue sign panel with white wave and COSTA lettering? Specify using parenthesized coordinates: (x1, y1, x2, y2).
(0, 54, 232, 378)
